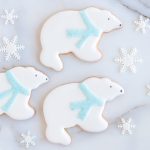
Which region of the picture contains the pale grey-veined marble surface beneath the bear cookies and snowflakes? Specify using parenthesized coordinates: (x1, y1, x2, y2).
(0, 0, 150, 150)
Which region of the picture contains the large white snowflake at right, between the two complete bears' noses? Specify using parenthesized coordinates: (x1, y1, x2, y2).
(115, 48, 142, 73)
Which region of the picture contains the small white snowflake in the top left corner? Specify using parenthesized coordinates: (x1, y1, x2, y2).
(1, 9, 18, 25)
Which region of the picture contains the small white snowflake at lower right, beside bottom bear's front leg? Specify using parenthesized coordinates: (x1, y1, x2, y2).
(118, 118, 135, 135)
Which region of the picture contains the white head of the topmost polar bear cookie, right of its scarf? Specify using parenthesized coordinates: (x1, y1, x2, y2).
(86, 7, 122, 32)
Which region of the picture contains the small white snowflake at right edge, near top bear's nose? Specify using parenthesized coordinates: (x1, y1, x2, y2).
(134, 16, 150, 33)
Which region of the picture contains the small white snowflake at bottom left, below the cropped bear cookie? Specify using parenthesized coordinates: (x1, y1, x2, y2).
(20, 131, 36, 149)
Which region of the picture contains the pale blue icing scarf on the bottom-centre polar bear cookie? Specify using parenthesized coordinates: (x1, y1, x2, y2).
(70, 83, 105, 120)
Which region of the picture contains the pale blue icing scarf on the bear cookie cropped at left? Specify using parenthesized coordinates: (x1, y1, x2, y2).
(0, 71, 30, 112)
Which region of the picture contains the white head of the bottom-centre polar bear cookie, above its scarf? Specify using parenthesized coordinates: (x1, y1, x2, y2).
(83, 77, 124, 101)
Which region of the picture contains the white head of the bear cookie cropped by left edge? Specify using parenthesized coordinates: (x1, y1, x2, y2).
(10, 67, 48, 90)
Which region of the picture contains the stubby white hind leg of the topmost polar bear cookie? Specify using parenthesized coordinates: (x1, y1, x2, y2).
(40, 50, 63, 71)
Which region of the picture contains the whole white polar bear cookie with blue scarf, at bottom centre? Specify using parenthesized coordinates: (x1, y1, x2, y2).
(43, 77, 124, 145)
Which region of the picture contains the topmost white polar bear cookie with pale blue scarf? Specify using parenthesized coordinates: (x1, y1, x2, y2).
(40, 7, 121, 71)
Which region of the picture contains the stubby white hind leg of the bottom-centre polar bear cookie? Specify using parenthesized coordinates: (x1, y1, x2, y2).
(46, 126, 71, 145)
